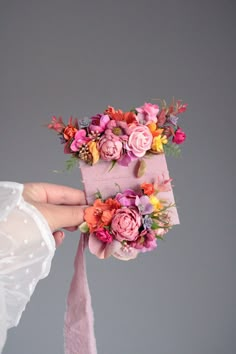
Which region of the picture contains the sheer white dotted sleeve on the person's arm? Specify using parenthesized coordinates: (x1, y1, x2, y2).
(0, 182, 55, 353)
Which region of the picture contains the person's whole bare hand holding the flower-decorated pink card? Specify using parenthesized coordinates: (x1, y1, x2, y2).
(23, 183, 86, 246)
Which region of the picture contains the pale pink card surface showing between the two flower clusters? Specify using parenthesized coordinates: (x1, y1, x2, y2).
(80, 154, 179, 225)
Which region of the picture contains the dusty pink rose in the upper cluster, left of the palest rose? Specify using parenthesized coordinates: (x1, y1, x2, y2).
(99, 135, 123, 161)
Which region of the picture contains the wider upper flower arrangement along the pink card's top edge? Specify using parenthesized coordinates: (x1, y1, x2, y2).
(47, 100, 187, 169)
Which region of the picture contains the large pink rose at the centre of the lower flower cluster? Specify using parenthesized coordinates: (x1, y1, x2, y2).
(111, 207, 141, 242)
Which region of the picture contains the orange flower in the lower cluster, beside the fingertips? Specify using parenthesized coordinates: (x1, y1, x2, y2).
(84, 198, 121, 232)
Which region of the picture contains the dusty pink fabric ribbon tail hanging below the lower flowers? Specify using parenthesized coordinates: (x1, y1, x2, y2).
(64, 234, 97, 354)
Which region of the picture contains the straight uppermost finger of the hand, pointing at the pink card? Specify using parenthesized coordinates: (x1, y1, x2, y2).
(23, 183, 86, 205)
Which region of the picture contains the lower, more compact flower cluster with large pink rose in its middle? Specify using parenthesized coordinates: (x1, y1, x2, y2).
(80, 177, 174, 260)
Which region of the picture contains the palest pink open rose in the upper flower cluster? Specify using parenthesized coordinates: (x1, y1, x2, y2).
(126, 125, 153, 157)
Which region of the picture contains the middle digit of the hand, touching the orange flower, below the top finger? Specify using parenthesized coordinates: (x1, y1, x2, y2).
(34, 203, 87, 231)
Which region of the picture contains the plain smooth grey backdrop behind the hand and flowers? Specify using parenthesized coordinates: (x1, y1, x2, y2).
(0, 0, 236, 354)
